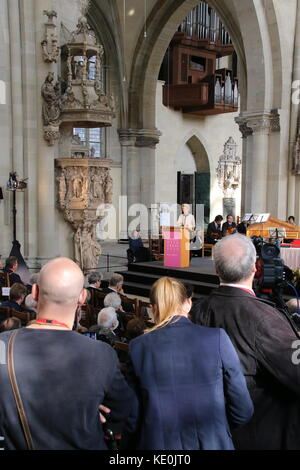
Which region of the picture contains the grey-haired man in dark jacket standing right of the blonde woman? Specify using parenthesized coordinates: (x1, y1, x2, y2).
(191, 234, 300, 450)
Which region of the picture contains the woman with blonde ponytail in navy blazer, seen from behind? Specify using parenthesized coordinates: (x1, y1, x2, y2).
(127, 278, 253, 450)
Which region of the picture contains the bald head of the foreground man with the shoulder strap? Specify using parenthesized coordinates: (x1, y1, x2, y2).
(38, 258, 84, 306)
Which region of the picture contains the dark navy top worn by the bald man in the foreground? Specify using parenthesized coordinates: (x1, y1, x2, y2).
(0, 328, 137, 450)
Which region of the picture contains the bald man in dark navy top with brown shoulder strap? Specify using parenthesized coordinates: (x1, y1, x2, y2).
(0, 258, 137, 450)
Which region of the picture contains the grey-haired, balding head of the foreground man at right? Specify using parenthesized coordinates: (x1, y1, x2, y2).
(214, 234, 256, 283)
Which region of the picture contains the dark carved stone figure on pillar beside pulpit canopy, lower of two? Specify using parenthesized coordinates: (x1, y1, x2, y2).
(42, 72, 61, 126)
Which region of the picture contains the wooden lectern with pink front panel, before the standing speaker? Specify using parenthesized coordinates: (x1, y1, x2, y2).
(162, 227, 190, 268)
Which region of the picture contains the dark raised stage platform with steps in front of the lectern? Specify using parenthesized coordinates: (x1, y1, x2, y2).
(120, 258, 219, 297)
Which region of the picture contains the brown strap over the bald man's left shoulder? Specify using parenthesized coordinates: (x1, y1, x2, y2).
(7, 330, 34, 450)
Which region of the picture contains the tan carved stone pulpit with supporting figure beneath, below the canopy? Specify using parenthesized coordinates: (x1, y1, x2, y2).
(55, 158, 113, 271)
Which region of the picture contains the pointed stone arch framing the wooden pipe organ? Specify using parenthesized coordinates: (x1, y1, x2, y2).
(129, 0, 281, 129)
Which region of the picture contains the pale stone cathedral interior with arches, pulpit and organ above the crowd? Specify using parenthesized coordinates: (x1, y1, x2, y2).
(0, 0, 300, 269)
